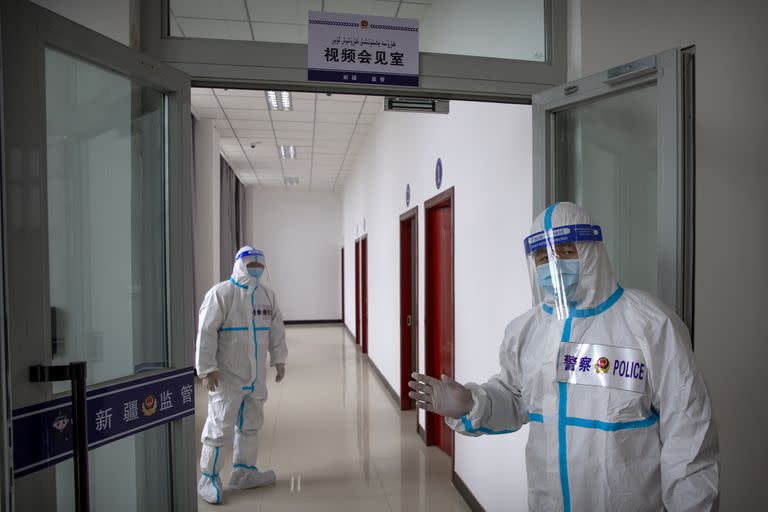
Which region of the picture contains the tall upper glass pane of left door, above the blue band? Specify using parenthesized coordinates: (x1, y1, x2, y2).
(45, 49, 167, 392)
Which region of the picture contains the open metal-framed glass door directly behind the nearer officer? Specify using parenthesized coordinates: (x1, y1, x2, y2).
(533, 50, 693, 327)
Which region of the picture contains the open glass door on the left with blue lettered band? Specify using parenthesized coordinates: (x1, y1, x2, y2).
(0, 0, 196, 511)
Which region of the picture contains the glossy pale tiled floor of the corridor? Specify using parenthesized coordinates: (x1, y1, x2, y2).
(196, 326, 469, 512)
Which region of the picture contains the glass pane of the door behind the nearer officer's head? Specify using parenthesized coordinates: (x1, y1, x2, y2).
(555, 86, 657, 294)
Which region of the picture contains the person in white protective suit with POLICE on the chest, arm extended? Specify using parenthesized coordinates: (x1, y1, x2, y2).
(409, 203, 719, 511)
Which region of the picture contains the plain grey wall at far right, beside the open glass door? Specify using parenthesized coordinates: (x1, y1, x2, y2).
(569, 0, 768, 504)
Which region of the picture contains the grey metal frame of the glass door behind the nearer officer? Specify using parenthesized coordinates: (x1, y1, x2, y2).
(533, 49, 693, 327)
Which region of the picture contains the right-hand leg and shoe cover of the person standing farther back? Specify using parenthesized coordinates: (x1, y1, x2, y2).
(229, 392, 276, 489)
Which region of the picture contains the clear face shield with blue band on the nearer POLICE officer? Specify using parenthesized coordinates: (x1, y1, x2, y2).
(525, 224, 603, 320)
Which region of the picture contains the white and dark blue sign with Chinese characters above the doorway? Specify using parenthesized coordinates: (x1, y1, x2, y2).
(307, 11, 419, 87)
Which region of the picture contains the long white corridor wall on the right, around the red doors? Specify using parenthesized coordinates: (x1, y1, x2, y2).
(344, 101, 532, 511)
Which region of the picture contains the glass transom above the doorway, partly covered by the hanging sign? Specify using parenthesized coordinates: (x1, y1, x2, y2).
(169, 0, 546, 62)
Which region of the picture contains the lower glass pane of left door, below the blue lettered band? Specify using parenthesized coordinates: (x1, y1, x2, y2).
(54, 425, 171, 512)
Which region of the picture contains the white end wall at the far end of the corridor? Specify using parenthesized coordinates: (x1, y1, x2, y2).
(246, 187, 342, 320)
